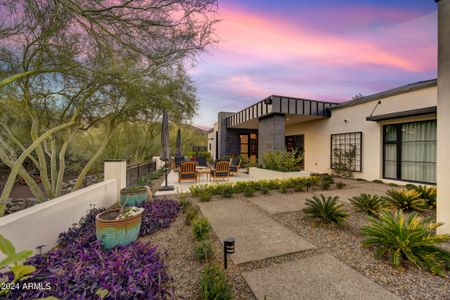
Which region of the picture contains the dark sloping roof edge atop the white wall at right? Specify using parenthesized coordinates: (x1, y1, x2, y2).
(331, 79, 437, 109)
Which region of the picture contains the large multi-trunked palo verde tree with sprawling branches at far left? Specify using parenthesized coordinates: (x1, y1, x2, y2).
(0, 0, 217, 215)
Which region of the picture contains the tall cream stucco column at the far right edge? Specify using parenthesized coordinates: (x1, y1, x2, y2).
(436, 0, 450, 234)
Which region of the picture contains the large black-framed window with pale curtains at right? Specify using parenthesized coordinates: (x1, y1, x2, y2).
(383, 120, 436, 183)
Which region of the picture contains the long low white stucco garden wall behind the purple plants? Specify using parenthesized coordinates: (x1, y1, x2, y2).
(0, 179, 118, 260)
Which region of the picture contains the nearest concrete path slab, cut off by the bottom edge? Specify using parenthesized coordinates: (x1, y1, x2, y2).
(243, 254, 400, 300)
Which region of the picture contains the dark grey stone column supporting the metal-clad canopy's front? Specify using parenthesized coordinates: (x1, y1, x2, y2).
(258, 114, 286, 164)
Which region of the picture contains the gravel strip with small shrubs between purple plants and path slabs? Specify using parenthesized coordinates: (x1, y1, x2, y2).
(141, 196, 255, 299)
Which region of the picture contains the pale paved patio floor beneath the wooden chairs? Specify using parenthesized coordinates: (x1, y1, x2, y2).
(155, 171, 255, 196)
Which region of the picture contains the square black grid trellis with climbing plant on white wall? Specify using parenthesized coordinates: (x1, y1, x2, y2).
(330, 132, 362, 172)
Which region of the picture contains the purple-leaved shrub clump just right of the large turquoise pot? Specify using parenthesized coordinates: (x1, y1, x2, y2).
(142, 198, 180, 235)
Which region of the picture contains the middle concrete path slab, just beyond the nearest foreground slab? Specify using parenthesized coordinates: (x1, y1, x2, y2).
(199, 200, 316, 264)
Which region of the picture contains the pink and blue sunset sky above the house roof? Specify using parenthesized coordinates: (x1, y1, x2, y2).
(191, 0, 437, 128)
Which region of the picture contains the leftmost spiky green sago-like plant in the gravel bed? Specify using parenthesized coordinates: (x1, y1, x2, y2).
(303, 194, 350, 225)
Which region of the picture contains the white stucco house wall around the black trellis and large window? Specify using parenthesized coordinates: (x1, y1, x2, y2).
(286, 87, 437, 181)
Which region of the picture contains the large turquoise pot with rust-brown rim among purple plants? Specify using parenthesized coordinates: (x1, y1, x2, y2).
(95, 195, 144, 249)
